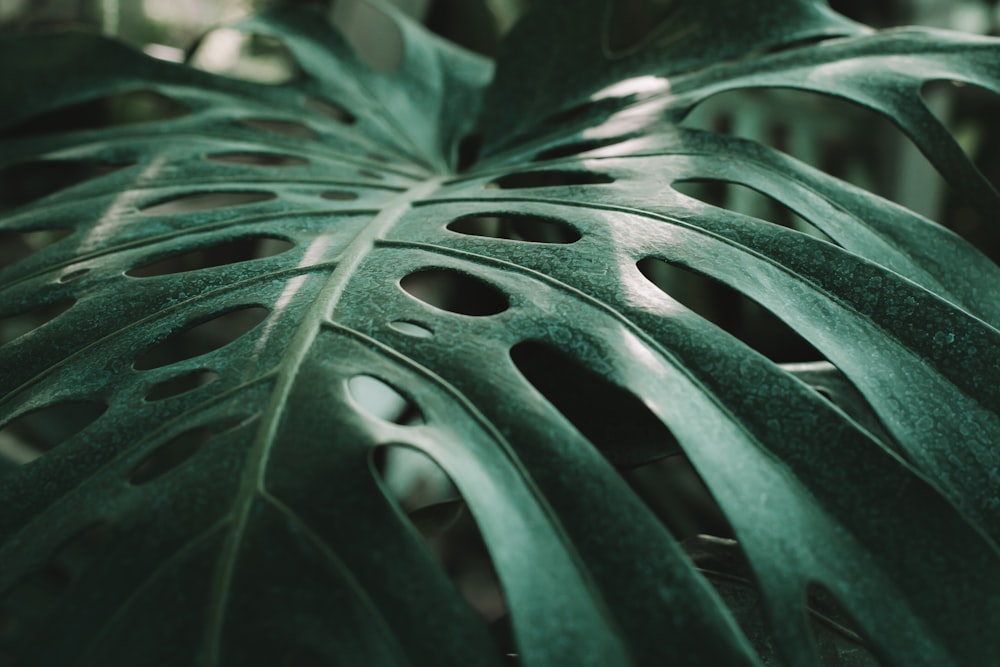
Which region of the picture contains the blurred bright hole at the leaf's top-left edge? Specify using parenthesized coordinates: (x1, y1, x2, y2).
(187, 28, 300, 85)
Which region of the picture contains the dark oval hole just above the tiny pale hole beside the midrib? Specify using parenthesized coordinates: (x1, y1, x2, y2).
(399, 269, 510, 316)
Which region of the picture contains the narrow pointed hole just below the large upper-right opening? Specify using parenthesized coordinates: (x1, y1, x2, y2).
(671, 178, 839, 245)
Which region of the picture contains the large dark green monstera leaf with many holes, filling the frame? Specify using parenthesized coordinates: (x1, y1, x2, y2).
(0, 0, 1000, 667)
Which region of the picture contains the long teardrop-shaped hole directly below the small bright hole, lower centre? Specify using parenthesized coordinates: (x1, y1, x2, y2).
(372, 444, 507, 623)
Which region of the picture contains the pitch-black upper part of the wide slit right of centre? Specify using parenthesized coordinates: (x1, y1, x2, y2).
(510, 341, 680, 468)
